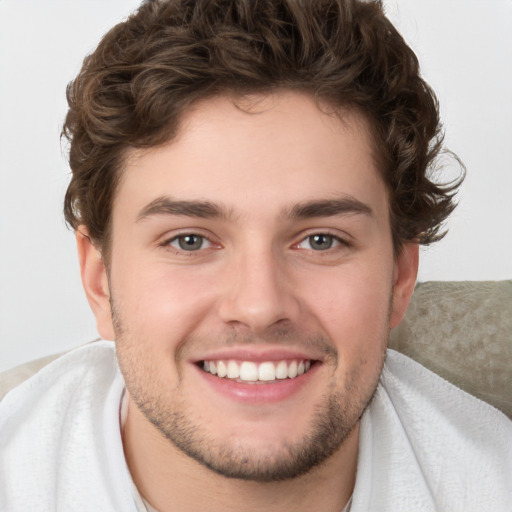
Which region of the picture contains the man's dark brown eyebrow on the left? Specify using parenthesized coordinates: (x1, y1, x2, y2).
(137, 197, 229, 222)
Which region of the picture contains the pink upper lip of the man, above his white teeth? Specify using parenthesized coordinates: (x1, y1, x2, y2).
(192, 347, 322, 363)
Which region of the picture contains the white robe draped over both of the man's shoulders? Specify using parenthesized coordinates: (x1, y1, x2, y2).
(0, 342, 512, 512)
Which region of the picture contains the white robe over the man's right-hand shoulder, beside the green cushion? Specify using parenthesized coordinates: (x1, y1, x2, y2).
(352, 351, 512, 511)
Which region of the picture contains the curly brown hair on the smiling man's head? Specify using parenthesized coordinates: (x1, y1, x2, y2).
(63, 0, 463, 251)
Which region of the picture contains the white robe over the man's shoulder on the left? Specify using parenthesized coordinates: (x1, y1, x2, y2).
(0, 341, 131, 510)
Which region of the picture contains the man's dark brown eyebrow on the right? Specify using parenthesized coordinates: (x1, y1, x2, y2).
(286, 196, 373, 219)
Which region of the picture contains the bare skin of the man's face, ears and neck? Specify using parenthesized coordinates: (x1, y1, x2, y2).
(77, 92, 418, 512)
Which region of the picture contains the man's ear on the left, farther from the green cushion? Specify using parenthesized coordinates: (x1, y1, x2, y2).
(75, 226, 115, 340)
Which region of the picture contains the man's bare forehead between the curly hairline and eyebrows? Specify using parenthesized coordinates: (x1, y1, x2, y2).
(117, 92, 387, 222)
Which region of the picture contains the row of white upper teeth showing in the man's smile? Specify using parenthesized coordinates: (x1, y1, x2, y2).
(202, 359, 311, 382)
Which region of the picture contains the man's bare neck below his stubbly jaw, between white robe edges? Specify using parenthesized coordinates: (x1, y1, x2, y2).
(123, 396, 359, 512)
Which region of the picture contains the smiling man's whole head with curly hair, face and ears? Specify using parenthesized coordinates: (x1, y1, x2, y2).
(64, 0, 462, 481)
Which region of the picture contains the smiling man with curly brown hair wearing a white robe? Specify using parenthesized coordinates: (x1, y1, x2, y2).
(0, 0, 512, 512)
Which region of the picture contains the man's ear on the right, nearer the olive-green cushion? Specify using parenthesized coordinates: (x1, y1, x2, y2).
(389, 243, 419, 329)
